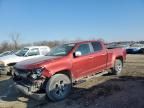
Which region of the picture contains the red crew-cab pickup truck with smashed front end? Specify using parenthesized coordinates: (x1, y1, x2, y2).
(13, 41, 126, 101)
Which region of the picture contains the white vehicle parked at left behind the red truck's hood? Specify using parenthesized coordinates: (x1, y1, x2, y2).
(0, 46, 50, 74)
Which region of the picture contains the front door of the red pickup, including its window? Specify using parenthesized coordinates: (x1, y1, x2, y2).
(72, 43, 93, 78)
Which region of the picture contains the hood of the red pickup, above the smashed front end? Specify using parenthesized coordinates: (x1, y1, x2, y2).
(15, 56, 62, 69)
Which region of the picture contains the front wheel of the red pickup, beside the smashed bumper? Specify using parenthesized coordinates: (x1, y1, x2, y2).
(46, 74, 72, 101)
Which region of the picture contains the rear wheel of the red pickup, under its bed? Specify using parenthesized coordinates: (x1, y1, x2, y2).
(112, 59, 123, 75)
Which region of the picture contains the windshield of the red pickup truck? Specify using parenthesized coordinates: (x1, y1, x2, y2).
(47, 44, 75, 56)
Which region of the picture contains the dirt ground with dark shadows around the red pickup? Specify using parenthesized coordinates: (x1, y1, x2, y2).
(0, 55, 144, 108)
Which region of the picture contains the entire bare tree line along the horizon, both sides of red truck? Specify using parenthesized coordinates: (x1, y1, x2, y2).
(0, 33, 144, 53)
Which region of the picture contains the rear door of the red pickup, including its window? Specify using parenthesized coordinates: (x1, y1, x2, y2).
(91, 41, 107, 72)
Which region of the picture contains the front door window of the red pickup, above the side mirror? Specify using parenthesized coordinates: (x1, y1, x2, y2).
(76, 44, 91, 55)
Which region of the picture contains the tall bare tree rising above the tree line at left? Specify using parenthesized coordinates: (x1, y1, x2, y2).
(10, 33, 20, 49)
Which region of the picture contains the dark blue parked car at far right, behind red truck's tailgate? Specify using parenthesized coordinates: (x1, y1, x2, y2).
(126, 44, 144, 54)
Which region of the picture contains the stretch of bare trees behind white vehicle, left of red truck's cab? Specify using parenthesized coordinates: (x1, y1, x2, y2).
(0, 33, 77, 53)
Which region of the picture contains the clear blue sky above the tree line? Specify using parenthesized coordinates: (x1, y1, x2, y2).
(0, 0, 144, 43)
